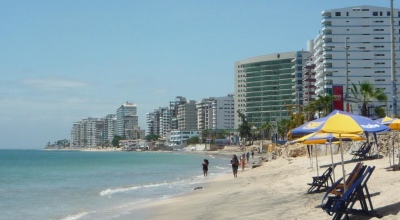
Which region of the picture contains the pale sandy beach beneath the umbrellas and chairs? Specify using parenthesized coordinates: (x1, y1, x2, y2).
(139, 150, 400, 220)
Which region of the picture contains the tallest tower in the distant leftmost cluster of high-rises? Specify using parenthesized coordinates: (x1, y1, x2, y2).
(115, 102, 138, 137)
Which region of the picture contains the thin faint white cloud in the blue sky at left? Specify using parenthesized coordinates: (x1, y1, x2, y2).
(22, 77, 90, 90)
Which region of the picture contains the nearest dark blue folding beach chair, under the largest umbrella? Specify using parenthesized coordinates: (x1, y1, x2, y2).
(321, 167, 374, 220)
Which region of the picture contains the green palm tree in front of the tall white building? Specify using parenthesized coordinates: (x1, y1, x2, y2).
(350, 81, 387, 117)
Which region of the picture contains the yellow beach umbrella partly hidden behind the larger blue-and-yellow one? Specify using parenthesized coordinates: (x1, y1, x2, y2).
(293, 132, 366, 182)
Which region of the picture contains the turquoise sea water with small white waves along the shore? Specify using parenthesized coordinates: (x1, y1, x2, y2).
(0, 150, 230, 220)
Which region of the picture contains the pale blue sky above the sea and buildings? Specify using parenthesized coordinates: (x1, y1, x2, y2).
(0, 0, 400, 149)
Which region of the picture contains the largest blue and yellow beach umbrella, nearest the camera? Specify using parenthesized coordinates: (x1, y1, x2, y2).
(290, 110, 391, 191)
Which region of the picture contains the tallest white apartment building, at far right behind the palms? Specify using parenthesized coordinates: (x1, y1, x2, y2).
(314, 5, 400, 114)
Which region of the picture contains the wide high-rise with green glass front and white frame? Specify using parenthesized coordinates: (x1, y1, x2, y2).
(234, 51, 311, 128)
